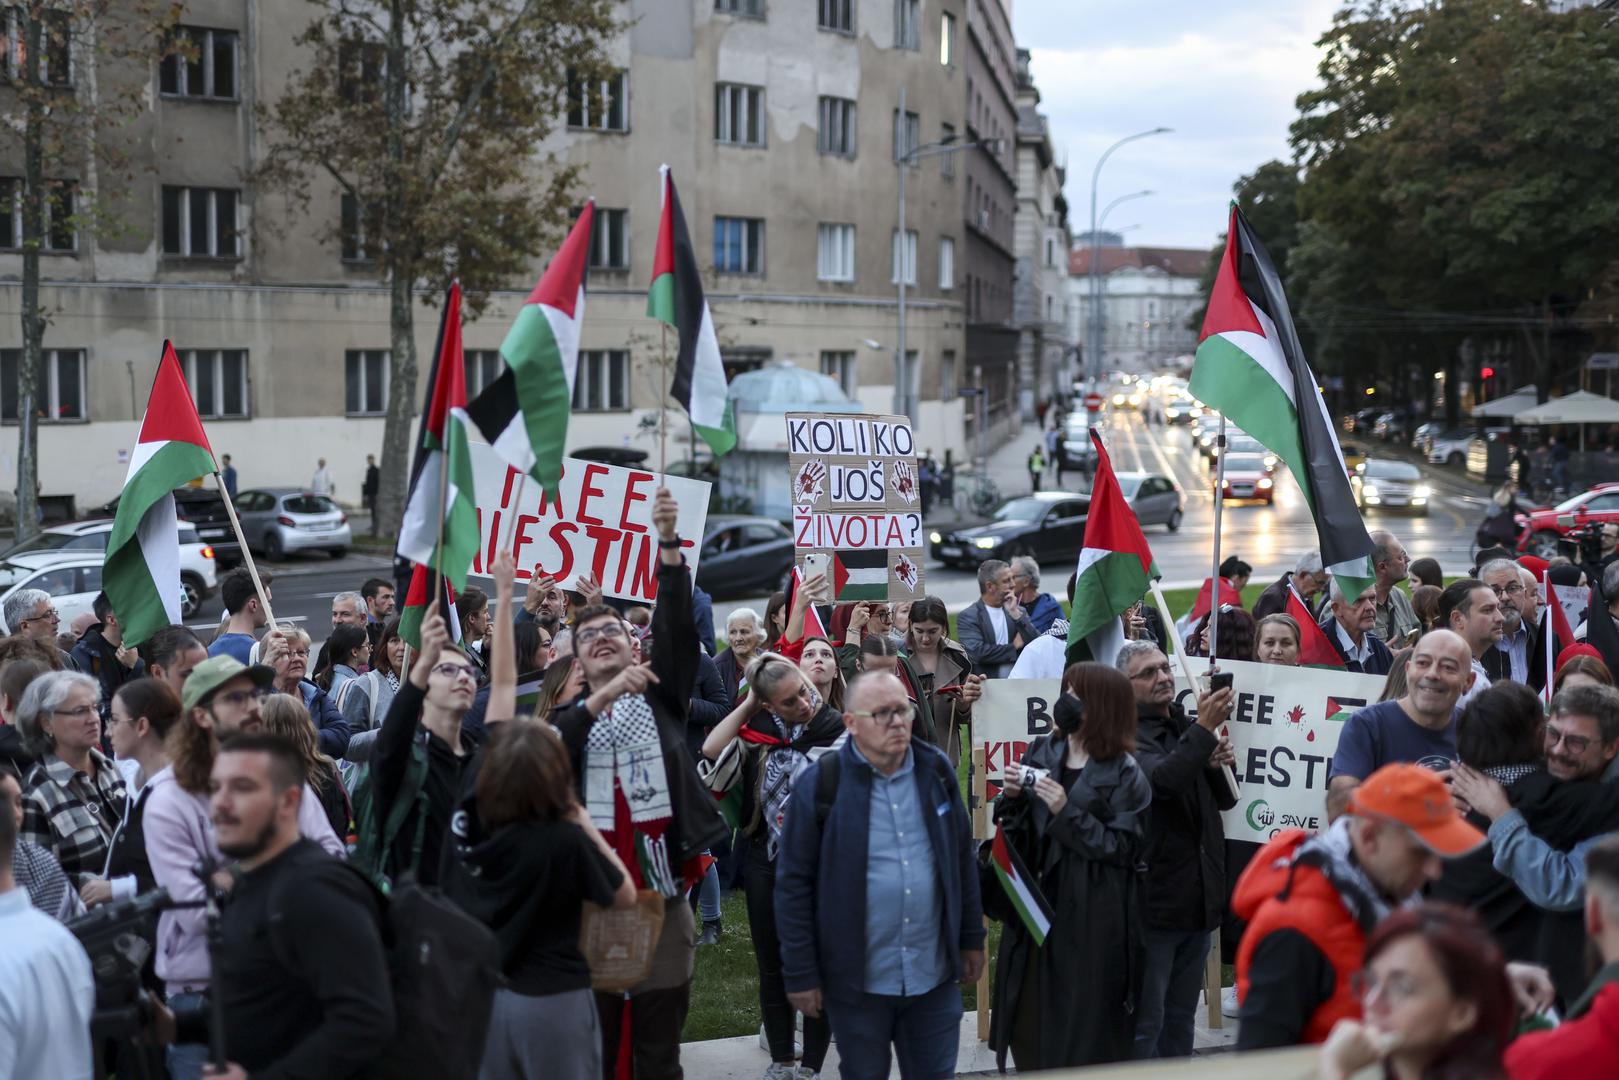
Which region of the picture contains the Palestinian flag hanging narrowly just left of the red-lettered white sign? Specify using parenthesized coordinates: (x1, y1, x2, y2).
(398, 283, 479, 615)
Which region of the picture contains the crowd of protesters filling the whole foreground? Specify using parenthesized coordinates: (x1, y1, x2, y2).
(9, 508, 1619, 1080)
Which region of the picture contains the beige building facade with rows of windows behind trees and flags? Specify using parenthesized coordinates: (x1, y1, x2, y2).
(0, 0, 971, 508)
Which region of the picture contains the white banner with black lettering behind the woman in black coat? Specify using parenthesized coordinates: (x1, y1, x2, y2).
(973, 661, 1384, 842)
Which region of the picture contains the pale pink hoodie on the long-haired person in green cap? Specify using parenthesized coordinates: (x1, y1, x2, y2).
(142, 769, 345, 994)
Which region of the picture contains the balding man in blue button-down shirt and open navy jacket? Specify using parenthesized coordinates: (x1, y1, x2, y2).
(776, 674, 984, 1080)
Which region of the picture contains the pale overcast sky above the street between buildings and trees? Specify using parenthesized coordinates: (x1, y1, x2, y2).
(1007, 0, 1342, 248)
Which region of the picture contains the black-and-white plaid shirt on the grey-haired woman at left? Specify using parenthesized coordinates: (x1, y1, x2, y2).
(21, 750, 125, 889)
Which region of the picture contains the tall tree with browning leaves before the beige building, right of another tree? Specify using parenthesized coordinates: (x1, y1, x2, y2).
(249, 0, 620, 533)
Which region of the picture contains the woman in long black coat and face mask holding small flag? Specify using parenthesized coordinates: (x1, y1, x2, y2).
(984, 664, 1153, 1074)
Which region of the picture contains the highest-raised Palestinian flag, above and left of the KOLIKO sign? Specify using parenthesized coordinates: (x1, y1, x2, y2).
(646, 165, 737, 457)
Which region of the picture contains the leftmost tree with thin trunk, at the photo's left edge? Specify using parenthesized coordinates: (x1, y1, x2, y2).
(0, 0, 183, 539)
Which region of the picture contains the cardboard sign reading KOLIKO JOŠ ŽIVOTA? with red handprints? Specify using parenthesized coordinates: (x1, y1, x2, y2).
(787, 413, 924, 602)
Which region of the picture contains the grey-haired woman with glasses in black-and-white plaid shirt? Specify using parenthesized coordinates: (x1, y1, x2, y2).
(16, 672, 125, 891)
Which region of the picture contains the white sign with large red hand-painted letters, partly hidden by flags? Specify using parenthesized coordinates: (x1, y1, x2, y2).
(459, 444, 709, 604)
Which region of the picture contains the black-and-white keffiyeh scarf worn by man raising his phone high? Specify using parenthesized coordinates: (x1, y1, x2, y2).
(584, 693, 680, 897)
